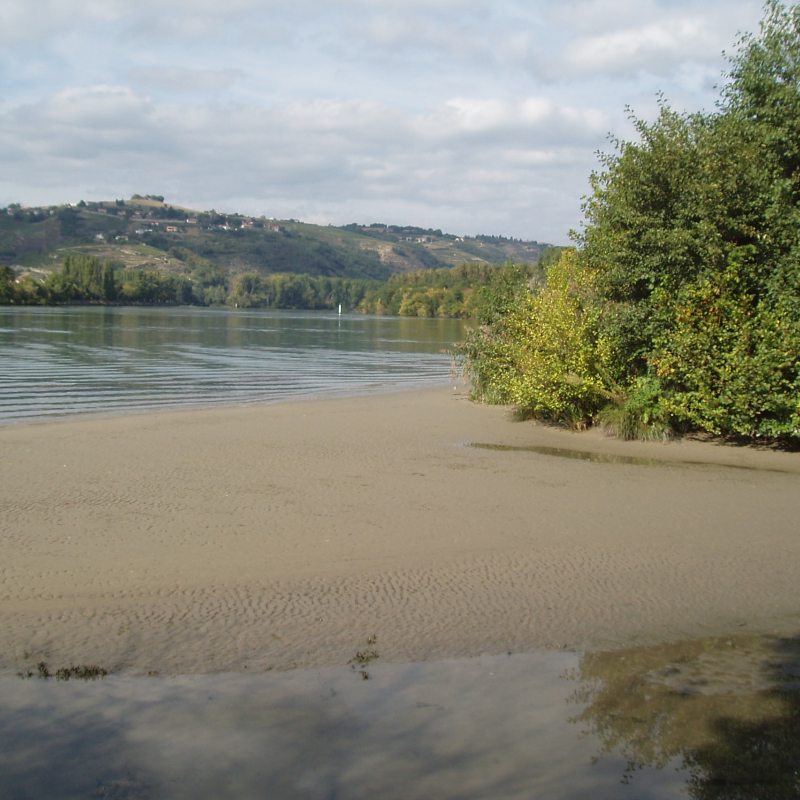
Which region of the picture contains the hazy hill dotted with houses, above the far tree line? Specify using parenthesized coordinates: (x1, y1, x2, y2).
(0, 195, 547, 283)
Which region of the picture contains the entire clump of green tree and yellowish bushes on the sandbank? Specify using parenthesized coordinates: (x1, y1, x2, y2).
(460, 2, 800, 440)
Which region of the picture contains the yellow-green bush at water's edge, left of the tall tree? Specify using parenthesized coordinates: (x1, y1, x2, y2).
(459, 250, 610, 426)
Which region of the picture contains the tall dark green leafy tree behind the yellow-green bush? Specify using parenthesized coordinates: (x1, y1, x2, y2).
(582, 2, 800, 435)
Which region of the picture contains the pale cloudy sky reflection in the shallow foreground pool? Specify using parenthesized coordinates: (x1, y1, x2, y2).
(0, 653, 683, 800)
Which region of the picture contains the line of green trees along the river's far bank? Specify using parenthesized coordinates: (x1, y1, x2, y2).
(0, 255, 561, 318)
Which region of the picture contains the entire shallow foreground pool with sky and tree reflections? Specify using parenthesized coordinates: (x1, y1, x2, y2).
(0, 638, 800, 800)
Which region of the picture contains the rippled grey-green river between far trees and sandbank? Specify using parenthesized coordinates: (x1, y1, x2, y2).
(0, 306, 463, 422)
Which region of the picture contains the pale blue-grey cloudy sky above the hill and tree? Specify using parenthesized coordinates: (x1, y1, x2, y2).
(0, 0, 763, 244)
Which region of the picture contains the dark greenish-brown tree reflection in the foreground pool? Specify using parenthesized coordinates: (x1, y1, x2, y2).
(568, 637, 800, 800)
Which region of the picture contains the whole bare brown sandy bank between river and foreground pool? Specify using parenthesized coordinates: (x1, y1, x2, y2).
(0, 389, 800, 673)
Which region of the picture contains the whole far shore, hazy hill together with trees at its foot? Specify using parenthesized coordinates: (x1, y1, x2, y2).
(0, 200, 554, 316)
